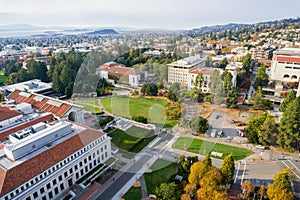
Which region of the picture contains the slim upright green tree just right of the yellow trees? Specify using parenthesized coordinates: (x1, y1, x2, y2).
(221, 154, 235, 184)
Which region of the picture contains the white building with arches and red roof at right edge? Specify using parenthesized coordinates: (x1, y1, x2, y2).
(270, 48, 300, 82)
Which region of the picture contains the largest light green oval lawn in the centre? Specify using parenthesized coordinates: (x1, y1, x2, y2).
(101, 97, 178, 128)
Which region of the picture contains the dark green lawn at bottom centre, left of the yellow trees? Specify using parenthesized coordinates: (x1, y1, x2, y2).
(144, 160, 178, 194)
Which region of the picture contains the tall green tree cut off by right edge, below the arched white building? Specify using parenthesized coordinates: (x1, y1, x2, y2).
(276, 97, 300, 150)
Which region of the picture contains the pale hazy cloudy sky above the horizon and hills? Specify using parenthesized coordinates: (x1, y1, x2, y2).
(0, 0, 300, 29)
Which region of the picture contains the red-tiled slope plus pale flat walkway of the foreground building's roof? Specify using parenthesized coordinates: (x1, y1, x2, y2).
(0, 122, 104, 196)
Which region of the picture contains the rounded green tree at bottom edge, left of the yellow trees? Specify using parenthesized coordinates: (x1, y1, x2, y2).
(154, 182, 177, 200)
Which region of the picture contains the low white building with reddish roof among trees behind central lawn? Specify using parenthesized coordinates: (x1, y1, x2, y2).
(96, 62, 148, 87)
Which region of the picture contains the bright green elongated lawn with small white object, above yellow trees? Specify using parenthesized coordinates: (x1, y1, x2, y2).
(173, 137, 253, 160)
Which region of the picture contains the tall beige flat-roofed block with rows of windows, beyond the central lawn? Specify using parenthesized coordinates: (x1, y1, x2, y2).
(168, 55, 206, 86)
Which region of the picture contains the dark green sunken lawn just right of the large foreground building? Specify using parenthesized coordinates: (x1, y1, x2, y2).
(108, 126, 156, 153)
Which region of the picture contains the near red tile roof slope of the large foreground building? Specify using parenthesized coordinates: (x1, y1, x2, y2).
(0, 128, 104, 196)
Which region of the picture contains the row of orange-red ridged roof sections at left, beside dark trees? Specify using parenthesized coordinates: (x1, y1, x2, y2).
(8, 90, 72, 117)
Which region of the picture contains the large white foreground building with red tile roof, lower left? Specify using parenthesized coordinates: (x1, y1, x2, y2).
(0, 121, 111, 200)
